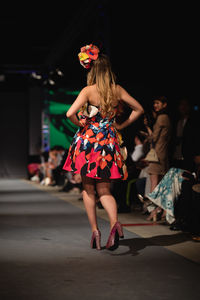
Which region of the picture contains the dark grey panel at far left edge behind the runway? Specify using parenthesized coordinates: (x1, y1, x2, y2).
(0, 91, 29, 178)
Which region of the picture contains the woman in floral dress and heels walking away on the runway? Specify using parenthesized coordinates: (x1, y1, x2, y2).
(63, 44, 143, 250)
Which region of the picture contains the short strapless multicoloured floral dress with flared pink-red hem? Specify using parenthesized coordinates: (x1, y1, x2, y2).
(63, 104, 128, 180)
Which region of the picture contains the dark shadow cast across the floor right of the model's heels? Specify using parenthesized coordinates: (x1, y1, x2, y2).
(116, 233, 191, 256)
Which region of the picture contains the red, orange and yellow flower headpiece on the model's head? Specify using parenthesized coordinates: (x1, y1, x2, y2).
(78, 44, 99, 69)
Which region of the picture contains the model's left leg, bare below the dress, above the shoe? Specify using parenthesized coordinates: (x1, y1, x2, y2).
(82, 176, 98, 232)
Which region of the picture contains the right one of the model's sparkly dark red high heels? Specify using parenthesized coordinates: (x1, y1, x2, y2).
(106, 222, 124, 251)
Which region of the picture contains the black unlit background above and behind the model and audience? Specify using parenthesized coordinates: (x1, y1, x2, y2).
(0, 0, 199, 177)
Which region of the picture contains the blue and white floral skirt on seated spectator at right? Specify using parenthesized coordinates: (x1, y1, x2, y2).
(147, 168, 184, 224)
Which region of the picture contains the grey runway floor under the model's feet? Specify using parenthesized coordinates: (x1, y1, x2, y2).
(0, 179, 200, 300)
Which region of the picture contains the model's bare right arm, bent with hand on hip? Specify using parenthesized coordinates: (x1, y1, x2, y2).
(115, 85, 144, 130)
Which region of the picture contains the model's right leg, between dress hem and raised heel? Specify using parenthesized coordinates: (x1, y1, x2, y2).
(96, 179, 118, 229)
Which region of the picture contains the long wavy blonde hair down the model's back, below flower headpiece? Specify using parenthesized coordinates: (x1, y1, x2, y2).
(87, 54, 117, 115)
